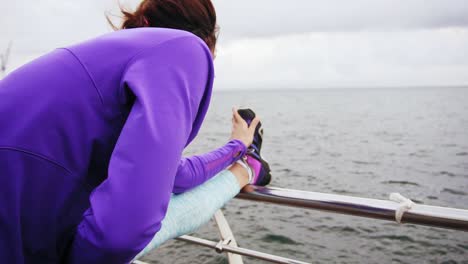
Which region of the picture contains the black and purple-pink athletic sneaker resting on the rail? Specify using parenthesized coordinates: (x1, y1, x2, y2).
(237, 108, 271, 186)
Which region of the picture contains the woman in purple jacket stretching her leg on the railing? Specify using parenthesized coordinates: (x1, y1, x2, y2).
(0, 0, 269, 263)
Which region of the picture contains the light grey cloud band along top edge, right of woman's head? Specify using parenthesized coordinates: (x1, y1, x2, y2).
(214, 0, 468, 38)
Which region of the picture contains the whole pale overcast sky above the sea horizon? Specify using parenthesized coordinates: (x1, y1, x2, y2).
(0, 0, 468, 89)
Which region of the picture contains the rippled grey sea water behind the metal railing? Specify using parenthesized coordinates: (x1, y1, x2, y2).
(144, 87, 468, 264)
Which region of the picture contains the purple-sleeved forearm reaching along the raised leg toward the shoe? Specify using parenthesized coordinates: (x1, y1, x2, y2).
(173, 139, 246, 194)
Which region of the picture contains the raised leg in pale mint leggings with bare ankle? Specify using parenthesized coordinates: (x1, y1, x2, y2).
(135, 163, 249, 259)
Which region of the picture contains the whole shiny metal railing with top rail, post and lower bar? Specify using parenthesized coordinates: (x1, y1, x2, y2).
(134, 185, 468, 264)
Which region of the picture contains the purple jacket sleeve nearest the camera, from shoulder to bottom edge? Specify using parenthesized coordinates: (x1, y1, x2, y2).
(69, 36, 213, 263)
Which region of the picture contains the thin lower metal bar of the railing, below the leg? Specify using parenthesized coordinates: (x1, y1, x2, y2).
(176, 236, 310, 264)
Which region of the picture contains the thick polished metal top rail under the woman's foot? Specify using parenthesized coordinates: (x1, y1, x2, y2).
(236, 185, 468, 231)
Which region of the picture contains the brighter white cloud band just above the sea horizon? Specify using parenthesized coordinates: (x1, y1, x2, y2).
(215, 29, 468, 88)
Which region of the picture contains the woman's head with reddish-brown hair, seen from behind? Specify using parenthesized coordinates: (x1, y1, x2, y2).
(111, 0, 217, 53)
